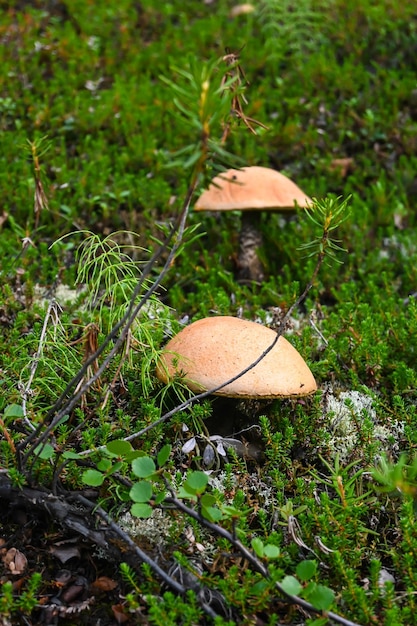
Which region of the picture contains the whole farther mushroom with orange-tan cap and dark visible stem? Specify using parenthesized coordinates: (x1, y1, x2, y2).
(194, 166, 312, 281)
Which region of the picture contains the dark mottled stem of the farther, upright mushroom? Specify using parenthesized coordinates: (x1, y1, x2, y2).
(237, 211, 265, 282)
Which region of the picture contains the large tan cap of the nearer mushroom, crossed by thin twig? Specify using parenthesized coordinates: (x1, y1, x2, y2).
(156, 316, 317, 398)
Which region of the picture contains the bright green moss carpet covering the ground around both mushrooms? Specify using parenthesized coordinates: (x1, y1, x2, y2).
(0, 0, 417, 626)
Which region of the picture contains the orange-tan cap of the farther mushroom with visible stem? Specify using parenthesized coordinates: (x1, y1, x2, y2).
(194, 165, 312, 211)
